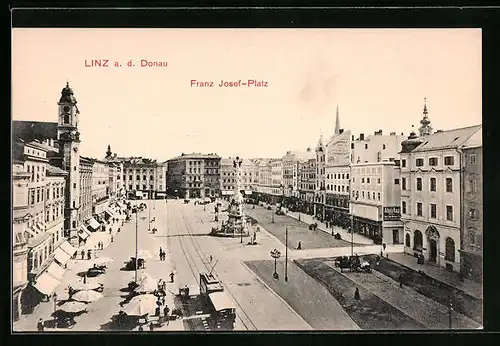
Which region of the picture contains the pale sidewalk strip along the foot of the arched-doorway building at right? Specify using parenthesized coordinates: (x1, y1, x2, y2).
(389, 253, 483, 299)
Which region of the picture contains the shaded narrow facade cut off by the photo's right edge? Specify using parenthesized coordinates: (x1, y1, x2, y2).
(460, 141, 483, 282)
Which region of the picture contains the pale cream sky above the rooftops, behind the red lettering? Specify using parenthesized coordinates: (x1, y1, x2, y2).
(12, 28, 482, 160)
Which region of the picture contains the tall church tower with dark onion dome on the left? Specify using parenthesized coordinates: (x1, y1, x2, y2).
(57, 83, 80, 244)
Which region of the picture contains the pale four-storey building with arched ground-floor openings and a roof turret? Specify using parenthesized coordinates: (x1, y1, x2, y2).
(400, 107, 481, 271)
